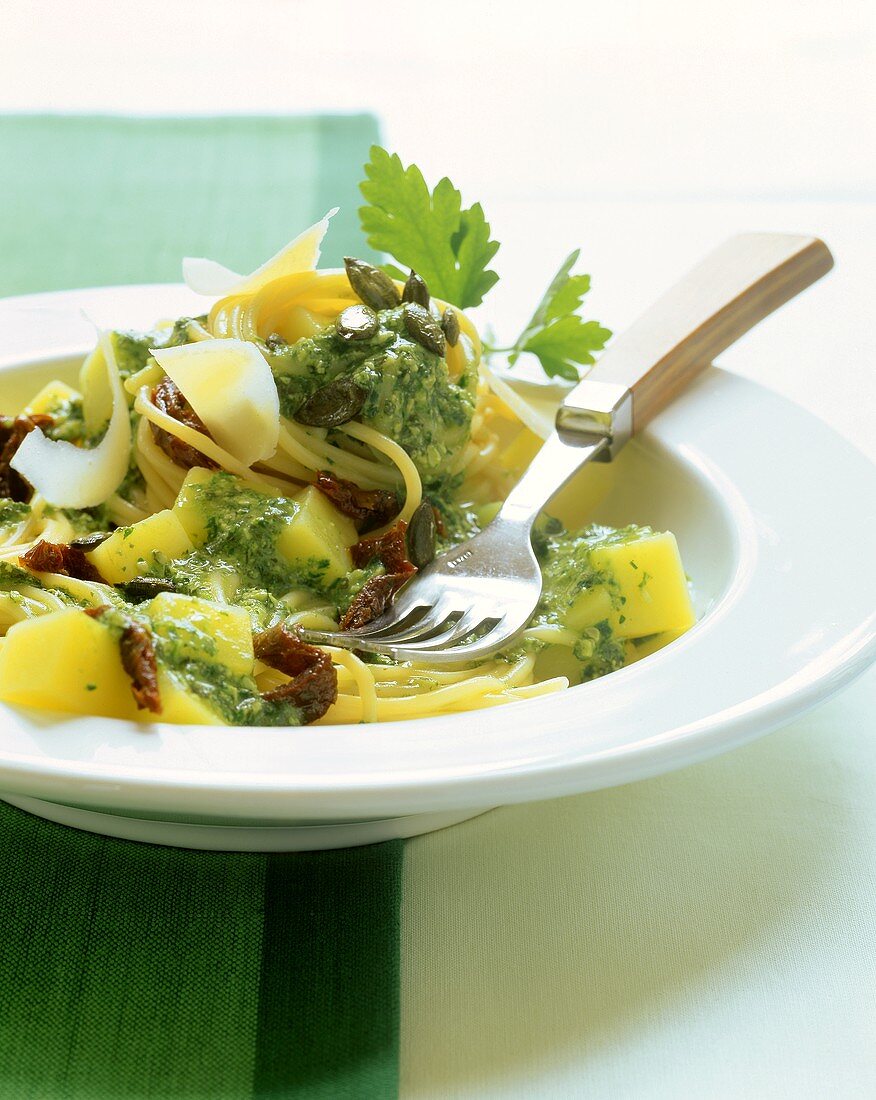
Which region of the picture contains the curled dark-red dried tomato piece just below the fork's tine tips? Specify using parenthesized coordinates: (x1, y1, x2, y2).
(252, 623, 338, 723)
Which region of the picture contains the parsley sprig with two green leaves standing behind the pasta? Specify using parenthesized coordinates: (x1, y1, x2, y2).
(359, 145, 611, 382)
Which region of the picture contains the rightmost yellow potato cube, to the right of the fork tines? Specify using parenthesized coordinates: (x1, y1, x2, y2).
(590, 531, 694, 638)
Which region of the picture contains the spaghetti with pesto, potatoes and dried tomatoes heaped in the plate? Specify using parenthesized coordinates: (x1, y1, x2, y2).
(0, 238, 692, 725)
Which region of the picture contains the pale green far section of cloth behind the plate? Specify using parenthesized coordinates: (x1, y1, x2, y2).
(0, 114, 377, 295)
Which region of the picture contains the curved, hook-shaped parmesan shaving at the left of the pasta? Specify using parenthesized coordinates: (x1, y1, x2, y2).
(10, 336, 131, 508)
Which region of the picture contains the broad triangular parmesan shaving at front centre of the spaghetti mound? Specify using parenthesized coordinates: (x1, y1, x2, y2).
(152, 339, 280, 466)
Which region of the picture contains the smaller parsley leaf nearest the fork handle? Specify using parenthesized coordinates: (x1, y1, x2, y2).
(508, 249, 611, 382)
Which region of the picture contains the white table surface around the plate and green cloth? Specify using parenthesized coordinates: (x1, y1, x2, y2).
(0, 0, 876, 1100)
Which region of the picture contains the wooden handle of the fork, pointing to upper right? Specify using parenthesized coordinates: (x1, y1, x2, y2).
(557, 233, 833, 450)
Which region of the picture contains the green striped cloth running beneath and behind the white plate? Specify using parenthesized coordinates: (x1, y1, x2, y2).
(0, 117, 402, 1100)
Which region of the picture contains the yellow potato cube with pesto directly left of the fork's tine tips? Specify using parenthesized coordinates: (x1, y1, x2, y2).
(145, 592, 254, 675)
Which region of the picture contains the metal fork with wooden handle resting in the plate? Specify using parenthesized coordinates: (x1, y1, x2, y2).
(302, 233, 833, 664)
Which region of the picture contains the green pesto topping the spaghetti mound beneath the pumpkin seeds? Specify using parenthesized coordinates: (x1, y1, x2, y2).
(263, 307, 478, 486)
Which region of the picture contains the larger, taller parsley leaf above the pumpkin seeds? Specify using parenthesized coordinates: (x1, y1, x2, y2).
(359, 145, 499, 309)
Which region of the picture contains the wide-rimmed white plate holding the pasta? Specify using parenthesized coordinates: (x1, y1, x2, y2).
(0, 286, 876, 850)
